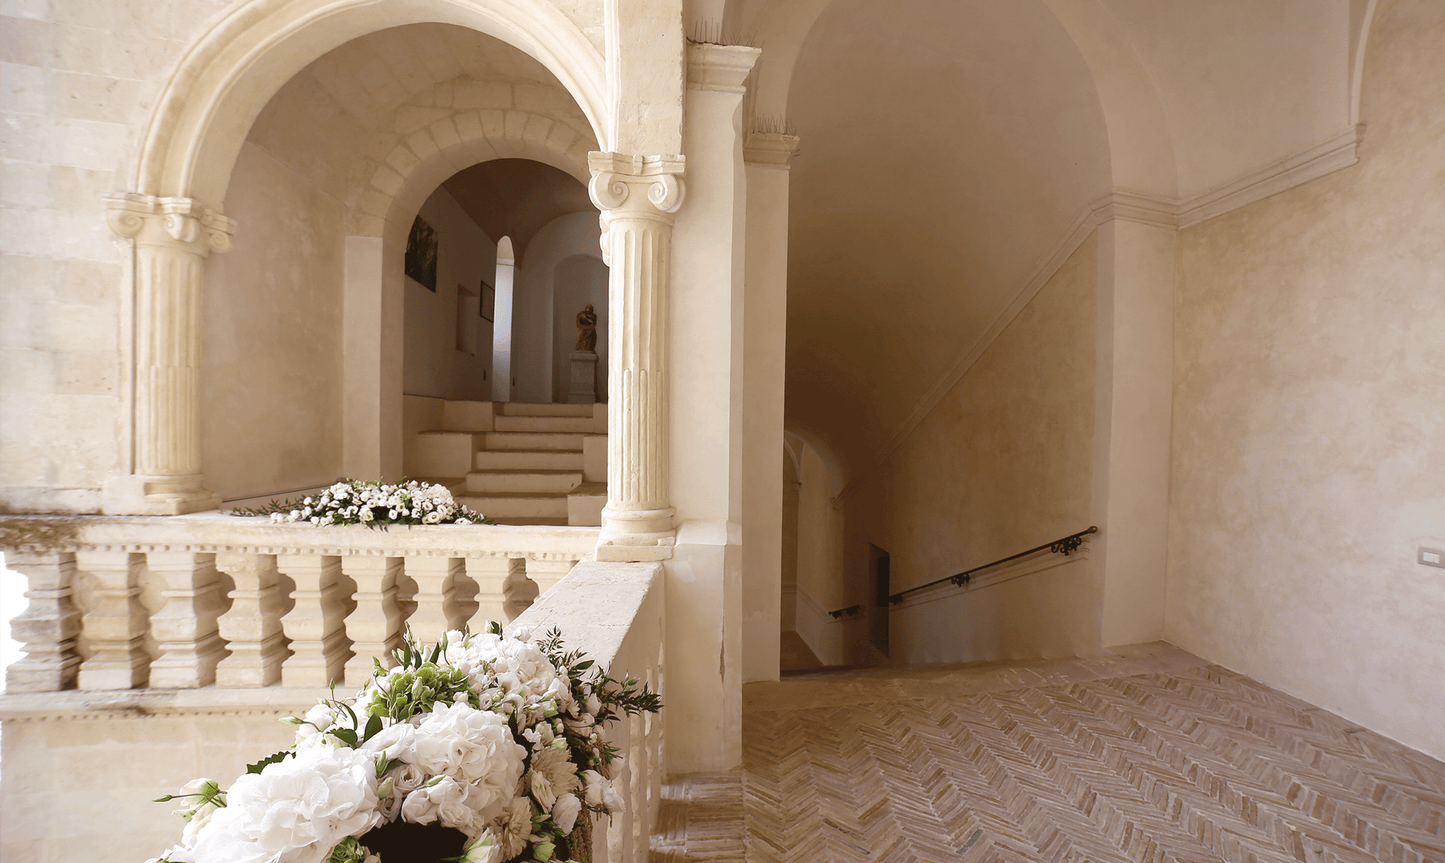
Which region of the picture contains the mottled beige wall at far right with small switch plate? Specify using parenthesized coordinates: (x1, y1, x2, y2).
(1166, 0, 1445, 756)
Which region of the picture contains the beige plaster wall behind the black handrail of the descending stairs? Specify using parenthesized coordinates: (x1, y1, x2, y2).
(843, 234, 1101, 665)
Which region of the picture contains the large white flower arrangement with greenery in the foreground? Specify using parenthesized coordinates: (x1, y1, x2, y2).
(150, 623, 662, 863)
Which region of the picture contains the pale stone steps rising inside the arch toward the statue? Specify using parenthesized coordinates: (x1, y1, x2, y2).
(406, 399, 607, 526)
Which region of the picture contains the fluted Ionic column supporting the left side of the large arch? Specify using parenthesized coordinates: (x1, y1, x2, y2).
(104, 195, 236, 515)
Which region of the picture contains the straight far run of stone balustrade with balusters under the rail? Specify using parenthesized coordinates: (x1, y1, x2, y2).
(6, 513, 598, 694)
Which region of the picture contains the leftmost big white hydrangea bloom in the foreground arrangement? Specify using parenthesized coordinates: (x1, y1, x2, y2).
(192, 747, 381, 863)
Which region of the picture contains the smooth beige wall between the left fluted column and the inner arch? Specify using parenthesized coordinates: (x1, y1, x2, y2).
(199, 142, 345, 500)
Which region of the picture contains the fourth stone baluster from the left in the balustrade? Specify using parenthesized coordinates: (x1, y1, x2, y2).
(212, 552, 286, 688)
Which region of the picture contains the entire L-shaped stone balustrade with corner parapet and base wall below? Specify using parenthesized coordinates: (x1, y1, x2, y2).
(0, 526, 668, 863)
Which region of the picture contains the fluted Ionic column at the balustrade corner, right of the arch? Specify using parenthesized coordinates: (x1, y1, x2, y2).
(588, 153, 683, 561)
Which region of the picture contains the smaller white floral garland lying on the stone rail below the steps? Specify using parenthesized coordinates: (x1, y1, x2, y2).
(231, 480, 491, 528)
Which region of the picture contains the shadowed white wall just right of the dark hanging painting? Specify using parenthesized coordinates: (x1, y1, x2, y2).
(402, 188, 497, 400)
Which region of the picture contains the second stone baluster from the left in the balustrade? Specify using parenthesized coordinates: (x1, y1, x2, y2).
(75, 549, 150, 690)
